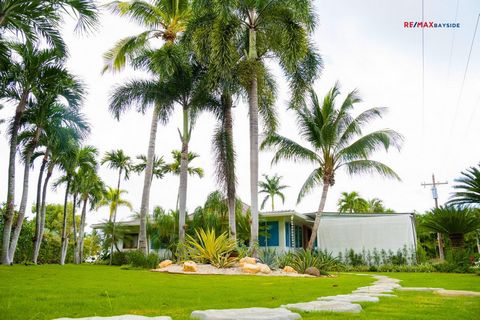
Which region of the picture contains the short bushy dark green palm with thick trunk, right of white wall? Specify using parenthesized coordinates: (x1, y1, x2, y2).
(422, 206, 480, 250)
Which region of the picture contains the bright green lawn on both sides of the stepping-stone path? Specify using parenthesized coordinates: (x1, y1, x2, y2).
(0, 265, 480, 320)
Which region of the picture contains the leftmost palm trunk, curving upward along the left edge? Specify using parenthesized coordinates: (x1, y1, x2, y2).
(1, 92, 28, 264)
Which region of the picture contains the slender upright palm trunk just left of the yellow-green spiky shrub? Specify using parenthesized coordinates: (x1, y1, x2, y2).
(178, 106, 190, 243)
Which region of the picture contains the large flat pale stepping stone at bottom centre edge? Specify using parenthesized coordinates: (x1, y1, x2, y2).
(190, 308, 302, 320)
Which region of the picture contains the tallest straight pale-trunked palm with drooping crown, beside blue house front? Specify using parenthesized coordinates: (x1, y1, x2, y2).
(192, 0, 319, 245)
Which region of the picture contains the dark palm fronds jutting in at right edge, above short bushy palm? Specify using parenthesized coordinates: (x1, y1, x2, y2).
(448, 164, 480, 207)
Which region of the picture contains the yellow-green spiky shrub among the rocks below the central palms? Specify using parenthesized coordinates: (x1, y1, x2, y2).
(186, 229, 237, 268)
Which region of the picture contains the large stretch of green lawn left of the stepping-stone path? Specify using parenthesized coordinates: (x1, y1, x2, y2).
(0, 265, 372, 320)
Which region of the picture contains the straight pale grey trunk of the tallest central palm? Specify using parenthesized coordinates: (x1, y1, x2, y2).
(248, 21, 258, 247)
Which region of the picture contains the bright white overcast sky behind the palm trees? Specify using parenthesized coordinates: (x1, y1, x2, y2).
(0, 0, 480, 229)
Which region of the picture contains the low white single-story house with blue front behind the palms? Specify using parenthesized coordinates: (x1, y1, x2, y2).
(92, 210, 416, 255)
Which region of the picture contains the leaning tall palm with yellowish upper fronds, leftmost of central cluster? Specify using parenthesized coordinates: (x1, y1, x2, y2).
(105, 0, 190, 253)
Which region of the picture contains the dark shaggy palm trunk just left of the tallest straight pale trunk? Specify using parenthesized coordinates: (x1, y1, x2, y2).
(223, 94, 237, 240)
